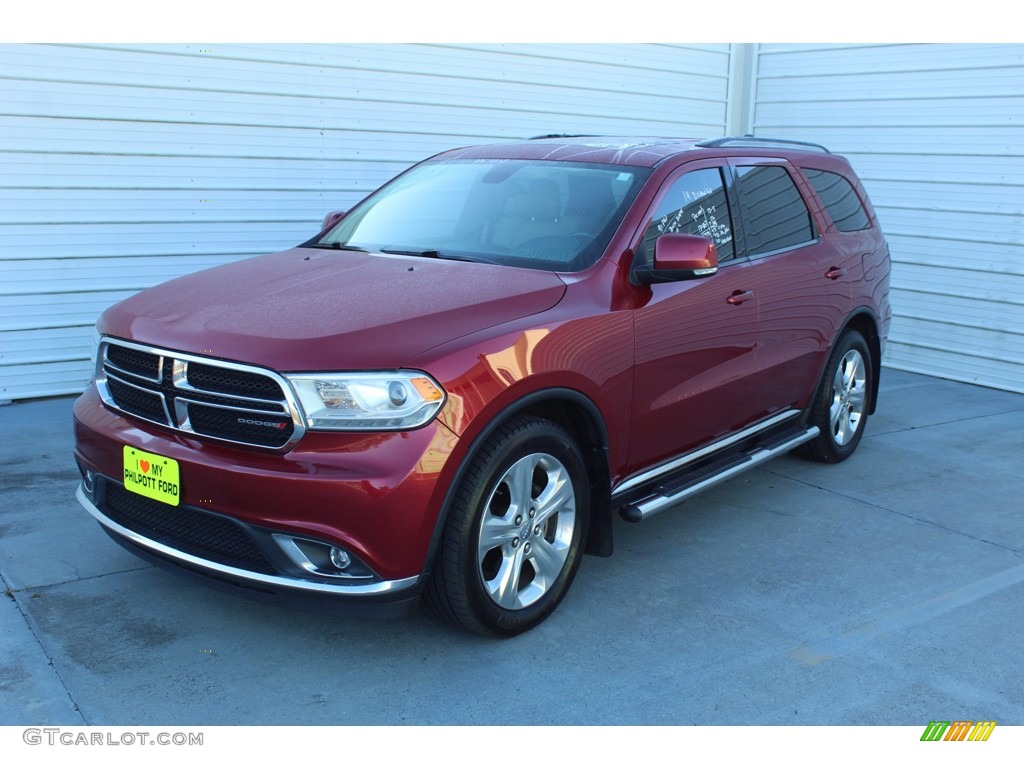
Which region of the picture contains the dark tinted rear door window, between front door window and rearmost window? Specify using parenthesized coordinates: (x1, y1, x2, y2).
(736, 165, 815, 256)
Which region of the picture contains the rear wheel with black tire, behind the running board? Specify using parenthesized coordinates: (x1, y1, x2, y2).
(797, 330, 874, 464)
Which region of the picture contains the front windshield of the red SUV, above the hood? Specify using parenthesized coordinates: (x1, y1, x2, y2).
(306, 160, 650, 271)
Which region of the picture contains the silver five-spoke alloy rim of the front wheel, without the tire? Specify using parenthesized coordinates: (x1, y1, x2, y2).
(477, 454, 577, 610)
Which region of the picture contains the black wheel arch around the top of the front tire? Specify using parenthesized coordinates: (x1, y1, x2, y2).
(424, 387, 612, 573)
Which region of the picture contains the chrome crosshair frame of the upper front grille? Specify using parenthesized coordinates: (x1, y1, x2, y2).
(95, 336, 306, 452)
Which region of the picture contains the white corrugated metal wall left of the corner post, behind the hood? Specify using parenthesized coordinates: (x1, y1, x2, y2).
(0, 45, 730, 400)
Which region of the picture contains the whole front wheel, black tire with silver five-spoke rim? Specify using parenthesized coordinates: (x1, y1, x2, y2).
(425, 417, 590, 637)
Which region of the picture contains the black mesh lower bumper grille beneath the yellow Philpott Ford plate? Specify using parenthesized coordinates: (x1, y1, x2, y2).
(99, 478, 278, 573)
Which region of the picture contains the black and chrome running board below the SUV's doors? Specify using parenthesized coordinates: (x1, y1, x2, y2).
(618, 427, 820, 522)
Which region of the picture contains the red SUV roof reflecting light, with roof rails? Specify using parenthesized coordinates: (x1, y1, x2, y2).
(438, 135, 836, 168)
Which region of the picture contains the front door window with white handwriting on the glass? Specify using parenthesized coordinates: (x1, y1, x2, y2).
(643, 168, 735, 261)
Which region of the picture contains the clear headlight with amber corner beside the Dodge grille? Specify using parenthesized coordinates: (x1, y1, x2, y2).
(286, 371, 444, 431)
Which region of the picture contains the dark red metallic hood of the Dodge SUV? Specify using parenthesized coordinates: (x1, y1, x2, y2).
(99, 248, 565, 371)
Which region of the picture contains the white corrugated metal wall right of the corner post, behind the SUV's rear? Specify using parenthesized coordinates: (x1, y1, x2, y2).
(754, 45, 1024, 392)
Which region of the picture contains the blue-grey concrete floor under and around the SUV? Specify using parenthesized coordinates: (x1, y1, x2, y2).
(0, 370, 1024, 728)
